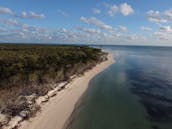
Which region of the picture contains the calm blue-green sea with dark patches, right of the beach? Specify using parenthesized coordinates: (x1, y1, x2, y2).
(67, 46, 172, 129)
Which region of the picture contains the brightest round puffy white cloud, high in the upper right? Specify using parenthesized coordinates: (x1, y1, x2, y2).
(120, 3, 134, 16)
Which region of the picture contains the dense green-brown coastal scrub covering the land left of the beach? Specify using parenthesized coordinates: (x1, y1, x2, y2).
(0, 44, 106, 116)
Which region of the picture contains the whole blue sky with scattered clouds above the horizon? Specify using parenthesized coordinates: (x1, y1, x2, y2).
(0, 0, 172, 46)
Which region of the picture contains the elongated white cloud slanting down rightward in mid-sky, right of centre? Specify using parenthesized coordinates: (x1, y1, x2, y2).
(80, 17, 113, 31)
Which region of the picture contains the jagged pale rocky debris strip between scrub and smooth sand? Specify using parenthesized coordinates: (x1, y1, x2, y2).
(0, 81, 69, 129)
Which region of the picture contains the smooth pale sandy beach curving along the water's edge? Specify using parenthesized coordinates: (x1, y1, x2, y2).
(19, 54, 114, 129)
